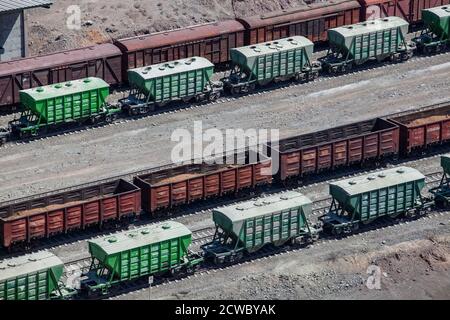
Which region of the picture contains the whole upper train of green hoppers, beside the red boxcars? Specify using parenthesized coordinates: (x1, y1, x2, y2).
(0, 6, 450, 144)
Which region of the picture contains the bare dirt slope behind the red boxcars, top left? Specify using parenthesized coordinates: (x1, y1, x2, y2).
(27, 0, 310, 55)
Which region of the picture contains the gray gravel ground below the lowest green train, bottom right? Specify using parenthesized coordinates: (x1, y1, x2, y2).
(113, 213, 450, 300)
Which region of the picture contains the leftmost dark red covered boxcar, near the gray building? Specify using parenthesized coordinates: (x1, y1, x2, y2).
(0, 43, 122, 111)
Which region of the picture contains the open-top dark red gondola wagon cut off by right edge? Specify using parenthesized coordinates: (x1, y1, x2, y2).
(389, 103, 450, 155)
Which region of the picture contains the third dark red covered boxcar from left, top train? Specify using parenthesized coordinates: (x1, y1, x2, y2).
(238, 0, 361, 45)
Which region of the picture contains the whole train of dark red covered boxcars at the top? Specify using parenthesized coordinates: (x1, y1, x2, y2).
(0, 0, 449, 111)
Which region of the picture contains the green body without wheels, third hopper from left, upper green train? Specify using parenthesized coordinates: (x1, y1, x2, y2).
(230, 36, 314, 82)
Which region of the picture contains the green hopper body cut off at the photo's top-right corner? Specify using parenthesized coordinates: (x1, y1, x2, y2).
(422, 5, 450, 40)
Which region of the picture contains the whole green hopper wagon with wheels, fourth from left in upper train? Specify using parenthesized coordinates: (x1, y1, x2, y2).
(320, 17, 414, 73)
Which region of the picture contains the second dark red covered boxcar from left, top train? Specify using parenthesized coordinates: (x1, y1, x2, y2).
(115, 20, 244, 78)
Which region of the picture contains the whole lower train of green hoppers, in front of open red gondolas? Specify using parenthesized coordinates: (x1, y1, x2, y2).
(0, 155, 450, 300)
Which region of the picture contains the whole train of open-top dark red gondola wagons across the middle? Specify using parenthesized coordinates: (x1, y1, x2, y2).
(0, 102, 450, 250)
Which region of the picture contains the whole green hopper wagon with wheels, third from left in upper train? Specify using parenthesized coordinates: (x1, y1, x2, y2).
(223, 36, 320, 93)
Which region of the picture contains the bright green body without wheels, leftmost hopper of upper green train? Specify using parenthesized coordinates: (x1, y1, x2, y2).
(19, 77, 109, 124)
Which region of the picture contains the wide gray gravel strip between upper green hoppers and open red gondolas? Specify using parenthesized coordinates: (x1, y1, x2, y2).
(0, 54, 450, 201)
